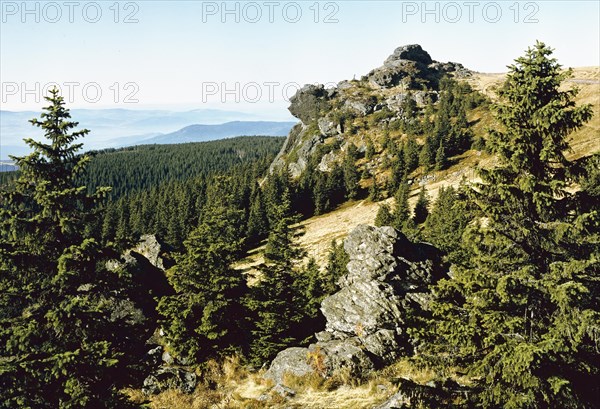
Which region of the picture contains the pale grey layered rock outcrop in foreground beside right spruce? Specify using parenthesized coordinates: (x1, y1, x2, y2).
(265, 225, 446, 383)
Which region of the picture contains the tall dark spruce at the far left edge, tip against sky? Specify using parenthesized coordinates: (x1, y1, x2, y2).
(0, 89, 149, 408)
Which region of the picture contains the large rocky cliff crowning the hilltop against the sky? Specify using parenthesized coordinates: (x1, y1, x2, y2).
(270, 45, 471, 177)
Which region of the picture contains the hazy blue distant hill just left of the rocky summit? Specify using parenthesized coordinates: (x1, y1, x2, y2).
(144, 121, 295, 144)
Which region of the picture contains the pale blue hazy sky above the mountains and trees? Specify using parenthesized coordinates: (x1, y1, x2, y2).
(0, 0, 600, 120)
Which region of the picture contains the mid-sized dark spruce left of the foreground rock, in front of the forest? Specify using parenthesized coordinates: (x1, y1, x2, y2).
(158, 178, 249, 362)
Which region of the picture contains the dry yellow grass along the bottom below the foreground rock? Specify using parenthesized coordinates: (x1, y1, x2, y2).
(126, 358, 446, 409)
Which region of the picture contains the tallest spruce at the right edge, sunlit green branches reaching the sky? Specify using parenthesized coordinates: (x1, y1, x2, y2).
(429, 42, 600, 408)
